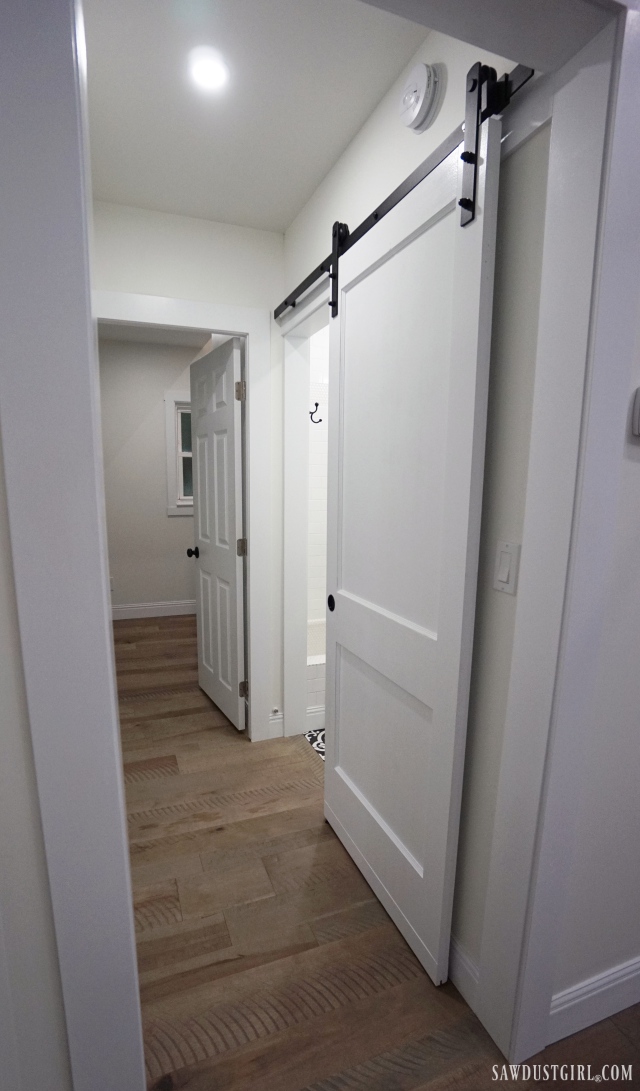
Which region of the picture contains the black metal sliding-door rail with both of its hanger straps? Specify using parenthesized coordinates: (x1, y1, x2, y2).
(274, 61, 533, 319)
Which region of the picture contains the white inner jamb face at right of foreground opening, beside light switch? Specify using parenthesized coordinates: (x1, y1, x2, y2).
(472, 19, 615, 1060)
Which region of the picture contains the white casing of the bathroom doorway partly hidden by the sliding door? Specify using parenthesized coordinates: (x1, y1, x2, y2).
(278, 279, 329, 735)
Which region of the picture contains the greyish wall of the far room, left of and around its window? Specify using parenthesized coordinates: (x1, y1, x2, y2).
(99, 337, 195, 606)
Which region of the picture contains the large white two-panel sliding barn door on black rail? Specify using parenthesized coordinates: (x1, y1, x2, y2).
(325, 119, 500, 984)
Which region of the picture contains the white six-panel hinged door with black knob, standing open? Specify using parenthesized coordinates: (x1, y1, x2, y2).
(191, 337, 245, 731)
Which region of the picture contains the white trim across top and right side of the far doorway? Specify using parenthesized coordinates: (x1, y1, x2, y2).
(93, 291, 273, 741)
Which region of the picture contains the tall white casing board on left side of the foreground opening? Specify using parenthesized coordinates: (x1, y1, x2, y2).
(0, 0, 145, 1091)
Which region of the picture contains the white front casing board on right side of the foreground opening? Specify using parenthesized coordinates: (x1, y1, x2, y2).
(504, 11, 640, 1060)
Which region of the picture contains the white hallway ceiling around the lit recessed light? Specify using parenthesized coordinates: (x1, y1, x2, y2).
(84, 0, 427, 231)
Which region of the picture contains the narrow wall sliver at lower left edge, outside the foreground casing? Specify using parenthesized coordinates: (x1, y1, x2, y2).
(0, 425, 71, 1091)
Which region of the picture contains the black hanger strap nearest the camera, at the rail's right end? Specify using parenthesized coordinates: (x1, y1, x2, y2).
(458, 61, 533, 227)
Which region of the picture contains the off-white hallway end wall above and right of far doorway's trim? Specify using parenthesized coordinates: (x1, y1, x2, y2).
(92, 202, 285, 708)
